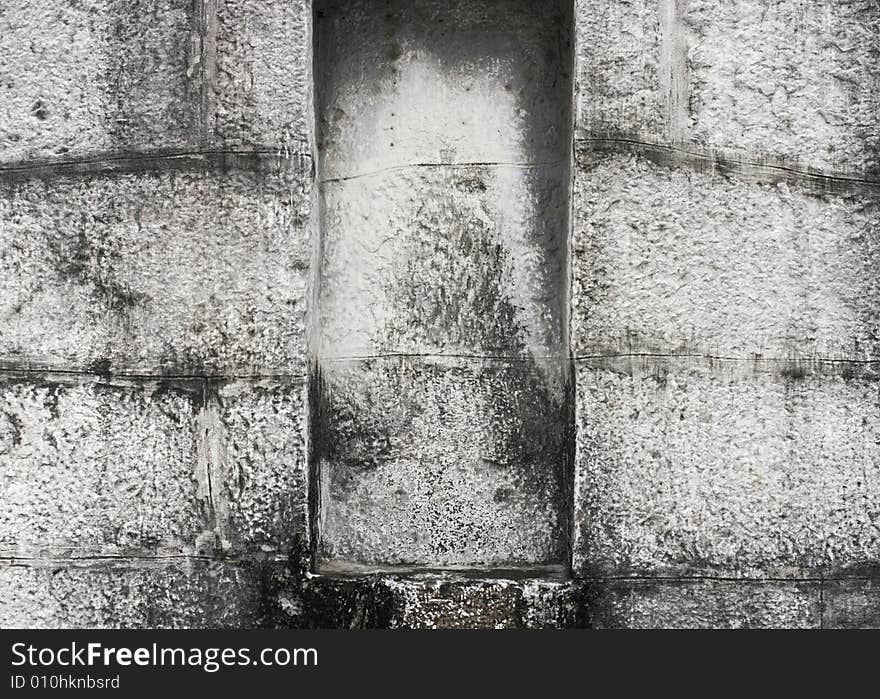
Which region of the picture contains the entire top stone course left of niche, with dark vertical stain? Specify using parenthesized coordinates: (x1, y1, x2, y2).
(0, 0, 312, 163)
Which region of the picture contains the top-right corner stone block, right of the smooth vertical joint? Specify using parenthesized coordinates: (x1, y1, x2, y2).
(683, 0, 880, 173)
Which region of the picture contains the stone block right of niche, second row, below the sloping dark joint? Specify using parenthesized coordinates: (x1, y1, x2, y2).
(572, 152, 880, 360)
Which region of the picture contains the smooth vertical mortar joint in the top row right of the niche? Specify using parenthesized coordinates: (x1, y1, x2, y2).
(659, 0, 690, 144)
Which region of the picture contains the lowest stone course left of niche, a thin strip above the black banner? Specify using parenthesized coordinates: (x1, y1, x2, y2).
(0, 559, 285, 629)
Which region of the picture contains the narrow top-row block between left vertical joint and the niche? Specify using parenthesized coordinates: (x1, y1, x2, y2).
(208, 0, 312, 153)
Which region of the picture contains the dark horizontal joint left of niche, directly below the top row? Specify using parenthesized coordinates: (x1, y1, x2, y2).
(0, 149, 312, 181)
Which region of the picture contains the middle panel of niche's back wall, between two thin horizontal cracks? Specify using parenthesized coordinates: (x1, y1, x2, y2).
(319, 165, 568, 357)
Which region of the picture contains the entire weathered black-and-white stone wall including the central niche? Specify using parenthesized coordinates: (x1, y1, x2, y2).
(0, 0, 880, 627)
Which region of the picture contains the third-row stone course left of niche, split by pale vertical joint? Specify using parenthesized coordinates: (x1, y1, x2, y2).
(0, 377, 306, 557)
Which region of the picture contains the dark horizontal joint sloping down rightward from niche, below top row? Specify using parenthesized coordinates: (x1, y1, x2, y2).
(575, 137, 880, 188)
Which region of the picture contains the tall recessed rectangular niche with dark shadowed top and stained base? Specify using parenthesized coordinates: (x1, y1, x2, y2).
(312, 0, 573, 571)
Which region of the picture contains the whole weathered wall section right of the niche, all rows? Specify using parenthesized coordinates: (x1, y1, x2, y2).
(571, 0, 880, 627)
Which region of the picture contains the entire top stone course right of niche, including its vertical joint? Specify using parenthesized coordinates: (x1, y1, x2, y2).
(577, 0, 880, 173)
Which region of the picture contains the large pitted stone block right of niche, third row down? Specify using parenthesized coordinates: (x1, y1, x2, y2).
(574, 358, 880, 577)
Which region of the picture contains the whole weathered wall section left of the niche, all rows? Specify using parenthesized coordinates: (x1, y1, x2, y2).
(0, 0, 312, 627)
